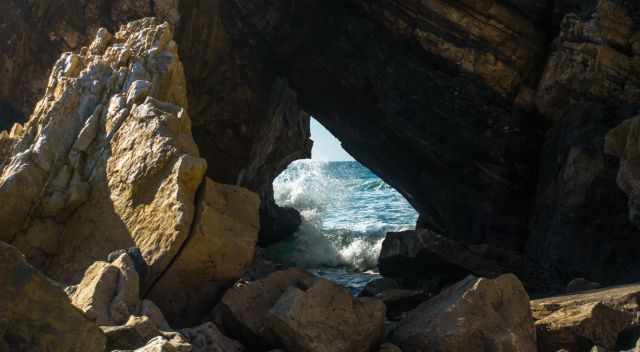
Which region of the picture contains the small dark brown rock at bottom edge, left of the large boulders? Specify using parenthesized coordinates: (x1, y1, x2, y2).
(180, 322, 244, 352)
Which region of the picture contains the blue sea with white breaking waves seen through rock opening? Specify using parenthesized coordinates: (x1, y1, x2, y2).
(267, 160, 418, 294)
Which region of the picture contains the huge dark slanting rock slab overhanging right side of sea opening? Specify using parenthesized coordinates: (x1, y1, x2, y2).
(289, 0, 542, 253)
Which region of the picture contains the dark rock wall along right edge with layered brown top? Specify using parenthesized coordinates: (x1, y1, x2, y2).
(527, 0, 640, 284)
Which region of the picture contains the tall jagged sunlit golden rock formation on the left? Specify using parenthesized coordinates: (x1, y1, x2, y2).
(0, 19, 260, 327)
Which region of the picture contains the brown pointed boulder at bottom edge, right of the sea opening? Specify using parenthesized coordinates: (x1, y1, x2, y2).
(389, 274, 537, 352)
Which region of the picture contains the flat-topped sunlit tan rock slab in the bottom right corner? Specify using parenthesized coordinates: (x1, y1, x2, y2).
(531, 285, 640, 351)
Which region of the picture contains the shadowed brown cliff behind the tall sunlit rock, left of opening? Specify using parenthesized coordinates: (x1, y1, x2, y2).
(0, 0, 311, 250)
